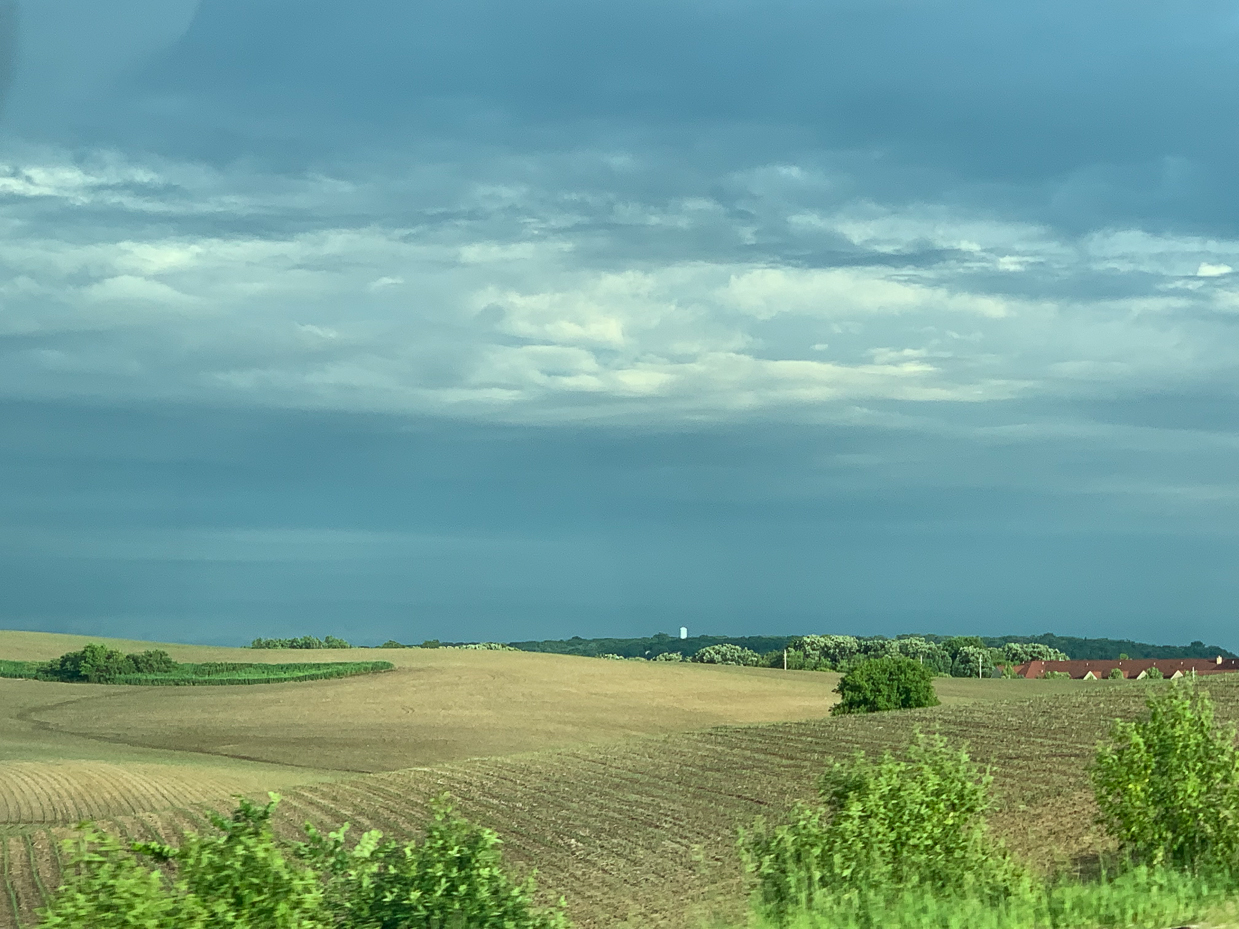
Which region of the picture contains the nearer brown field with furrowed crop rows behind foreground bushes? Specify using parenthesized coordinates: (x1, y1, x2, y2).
(9, 681, 1239, 929)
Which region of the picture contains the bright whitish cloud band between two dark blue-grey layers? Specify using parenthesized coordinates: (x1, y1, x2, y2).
(0, 149, 1239, 421)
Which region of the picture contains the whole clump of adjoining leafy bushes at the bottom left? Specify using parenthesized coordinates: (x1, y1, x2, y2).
(42, 794, 567, 929)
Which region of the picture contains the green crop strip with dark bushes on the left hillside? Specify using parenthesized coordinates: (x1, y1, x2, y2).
(0, 645, 393, 686)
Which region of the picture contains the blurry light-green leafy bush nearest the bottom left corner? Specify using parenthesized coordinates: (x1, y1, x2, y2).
(42, 795, 328, 929)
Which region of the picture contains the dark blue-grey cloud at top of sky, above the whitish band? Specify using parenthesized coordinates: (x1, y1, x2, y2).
(26, 0, 1219, 228)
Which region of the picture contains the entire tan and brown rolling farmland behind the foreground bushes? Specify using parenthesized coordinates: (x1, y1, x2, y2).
(0, 633, 1209, 929)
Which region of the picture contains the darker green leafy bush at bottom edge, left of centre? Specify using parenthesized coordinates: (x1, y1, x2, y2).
(299, 798, 567, 929)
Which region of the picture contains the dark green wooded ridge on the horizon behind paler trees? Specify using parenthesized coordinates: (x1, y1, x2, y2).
(508, 632, 1237, 660)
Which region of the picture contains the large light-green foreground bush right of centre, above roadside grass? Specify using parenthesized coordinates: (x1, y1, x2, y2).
(740, 733, 1031, 924)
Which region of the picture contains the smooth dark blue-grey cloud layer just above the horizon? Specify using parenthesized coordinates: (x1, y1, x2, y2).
(0, 404, 1239, 643)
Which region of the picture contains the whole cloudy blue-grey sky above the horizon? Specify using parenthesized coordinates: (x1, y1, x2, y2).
(0, 0, 1239, 649)
